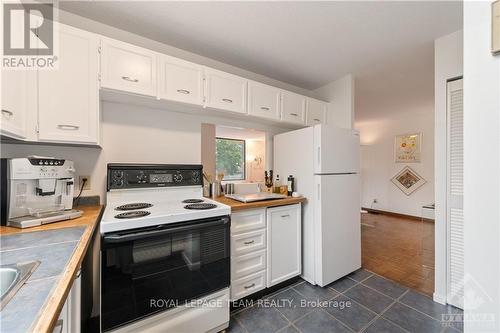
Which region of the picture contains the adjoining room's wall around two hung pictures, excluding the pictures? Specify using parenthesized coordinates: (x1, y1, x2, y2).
(356, 108, 434, 216)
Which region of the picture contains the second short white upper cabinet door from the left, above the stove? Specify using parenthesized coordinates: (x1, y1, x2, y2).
(159, 55, 203, 105)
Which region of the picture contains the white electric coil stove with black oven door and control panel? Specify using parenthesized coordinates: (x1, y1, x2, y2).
(100, 164, 231, 332)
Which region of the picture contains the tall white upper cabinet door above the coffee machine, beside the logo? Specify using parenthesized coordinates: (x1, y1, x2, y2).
(38, 24, 99, 144)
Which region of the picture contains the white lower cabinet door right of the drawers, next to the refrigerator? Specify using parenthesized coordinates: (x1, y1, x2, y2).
(267, 204, 302, 288)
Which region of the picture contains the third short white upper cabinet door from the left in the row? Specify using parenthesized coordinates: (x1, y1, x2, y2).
(204, 67, 247, 113)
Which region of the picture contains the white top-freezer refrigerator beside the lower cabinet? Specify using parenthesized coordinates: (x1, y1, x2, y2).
(273, 125, 361, 286)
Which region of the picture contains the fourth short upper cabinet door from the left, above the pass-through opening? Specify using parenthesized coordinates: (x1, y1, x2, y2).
(248, 81, 281, 120)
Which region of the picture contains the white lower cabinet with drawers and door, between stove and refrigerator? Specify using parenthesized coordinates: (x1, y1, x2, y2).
(231, 204, 302, 300)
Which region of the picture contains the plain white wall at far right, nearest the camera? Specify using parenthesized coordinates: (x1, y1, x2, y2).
(464, 1, 500, 332)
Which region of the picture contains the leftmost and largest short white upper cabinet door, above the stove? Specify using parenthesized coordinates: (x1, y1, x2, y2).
(101, 37, 158, 97)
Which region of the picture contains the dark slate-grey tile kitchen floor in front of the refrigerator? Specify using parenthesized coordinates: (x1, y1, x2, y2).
(227, 269, 463, 333)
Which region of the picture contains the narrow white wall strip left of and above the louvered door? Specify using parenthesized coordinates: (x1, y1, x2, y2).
(434, 31, 463, 303)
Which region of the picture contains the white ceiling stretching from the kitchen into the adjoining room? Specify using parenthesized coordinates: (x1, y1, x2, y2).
(60, 1, 462, 120)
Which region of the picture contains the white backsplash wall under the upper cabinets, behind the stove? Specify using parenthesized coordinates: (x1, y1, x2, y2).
(1, 102, 287, 200)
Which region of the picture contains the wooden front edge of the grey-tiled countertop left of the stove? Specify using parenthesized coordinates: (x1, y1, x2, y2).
(30, 206, 104, 333)
